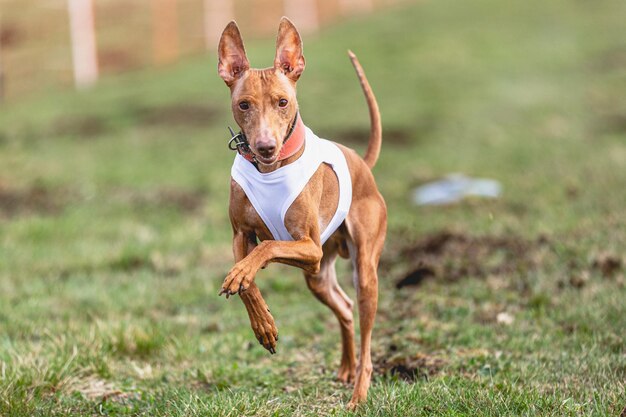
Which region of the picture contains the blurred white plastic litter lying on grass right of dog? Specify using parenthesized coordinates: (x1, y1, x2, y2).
(413, 174, 502, 205)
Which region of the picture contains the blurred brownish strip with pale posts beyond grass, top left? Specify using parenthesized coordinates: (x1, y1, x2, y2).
(0, 0, 401, 100)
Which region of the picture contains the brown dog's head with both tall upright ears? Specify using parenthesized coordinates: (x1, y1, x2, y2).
(218, 17, 305, 165)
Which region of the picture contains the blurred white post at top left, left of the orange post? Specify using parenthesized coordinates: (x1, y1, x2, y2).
(67, 0, 98, 88)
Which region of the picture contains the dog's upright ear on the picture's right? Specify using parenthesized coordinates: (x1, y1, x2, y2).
(274, 17, 305, 81)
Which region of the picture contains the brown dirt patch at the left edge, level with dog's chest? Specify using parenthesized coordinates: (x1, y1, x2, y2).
(0, 183, 66, 218)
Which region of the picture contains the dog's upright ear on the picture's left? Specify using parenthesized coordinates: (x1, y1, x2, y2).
(217, 20, 250, 87)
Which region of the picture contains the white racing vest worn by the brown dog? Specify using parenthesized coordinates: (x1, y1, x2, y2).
(230, 127, 352, 244)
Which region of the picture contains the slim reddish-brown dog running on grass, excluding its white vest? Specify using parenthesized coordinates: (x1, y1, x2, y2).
(218, 18, 387, 408)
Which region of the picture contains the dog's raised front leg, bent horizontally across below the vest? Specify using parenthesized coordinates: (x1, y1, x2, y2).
(220, 237, 322, 295)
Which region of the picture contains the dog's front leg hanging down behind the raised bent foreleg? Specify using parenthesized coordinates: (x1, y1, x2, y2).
(233, 232, 278, 354)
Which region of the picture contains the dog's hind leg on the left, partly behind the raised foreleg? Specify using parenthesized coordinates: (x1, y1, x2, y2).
(304, 247, 356, 382)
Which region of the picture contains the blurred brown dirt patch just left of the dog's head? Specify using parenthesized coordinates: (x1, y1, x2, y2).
(137, 103, 220, 127)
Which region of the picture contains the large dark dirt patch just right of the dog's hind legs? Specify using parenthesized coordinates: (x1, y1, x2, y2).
(381, 231, 547, 288)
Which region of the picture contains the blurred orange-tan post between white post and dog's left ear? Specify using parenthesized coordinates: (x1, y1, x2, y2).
(152, 0, 178, 64)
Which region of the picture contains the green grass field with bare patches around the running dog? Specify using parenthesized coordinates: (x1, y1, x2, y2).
(0, 0, 626, 416)
